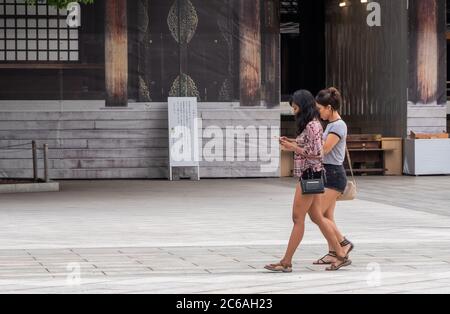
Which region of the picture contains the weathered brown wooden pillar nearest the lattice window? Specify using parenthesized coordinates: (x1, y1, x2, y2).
(105, 0, 128, 107)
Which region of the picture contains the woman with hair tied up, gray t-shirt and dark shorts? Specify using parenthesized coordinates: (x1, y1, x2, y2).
(309, 87, 354, 269)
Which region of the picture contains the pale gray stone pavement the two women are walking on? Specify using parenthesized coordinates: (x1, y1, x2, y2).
(0, 177, 450, 294)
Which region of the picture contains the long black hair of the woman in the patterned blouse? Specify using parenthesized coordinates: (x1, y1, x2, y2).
(289, 89, 319, 135)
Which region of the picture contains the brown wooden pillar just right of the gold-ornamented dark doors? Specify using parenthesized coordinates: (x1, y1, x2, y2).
(239, 0, 261, 106)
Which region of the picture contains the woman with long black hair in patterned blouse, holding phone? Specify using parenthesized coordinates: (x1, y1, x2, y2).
(265, 90, 351, 273)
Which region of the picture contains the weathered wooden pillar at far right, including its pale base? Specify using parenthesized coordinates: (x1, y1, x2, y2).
(406, 0, 447, 134)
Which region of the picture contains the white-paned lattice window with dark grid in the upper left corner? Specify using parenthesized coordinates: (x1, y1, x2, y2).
(0, 0, 79, 62)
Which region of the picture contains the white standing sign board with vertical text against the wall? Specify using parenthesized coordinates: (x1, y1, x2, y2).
(168, 97, 200, 180)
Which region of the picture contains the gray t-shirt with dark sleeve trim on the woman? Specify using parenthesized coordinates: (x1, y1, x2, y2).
(323, 120, 348, 166)
